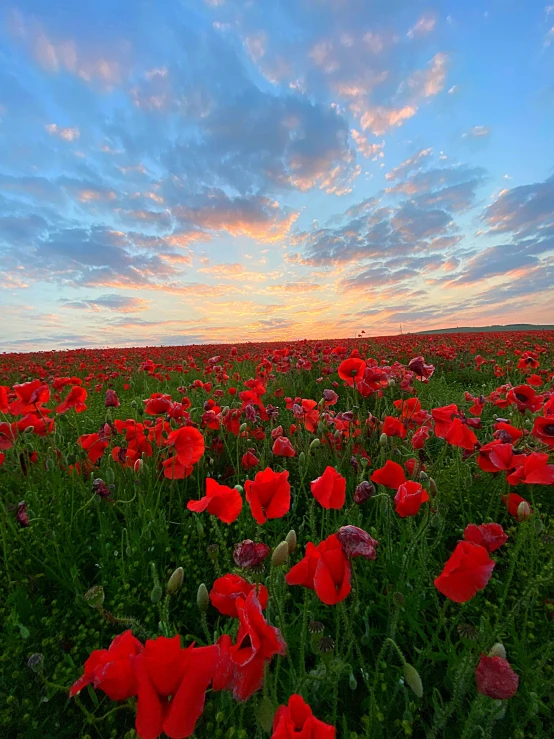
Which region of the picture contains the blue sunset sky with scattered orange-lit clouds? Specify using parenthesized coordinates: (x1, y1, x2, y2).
(0, 0, 554, 352)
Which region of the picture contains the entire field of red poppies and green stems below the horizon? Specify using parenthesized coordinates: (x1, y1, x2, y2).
(0, 331, 554, 739)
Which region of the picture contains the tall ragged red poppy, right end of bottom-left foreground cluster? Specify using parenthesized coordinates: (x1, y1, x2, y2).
(213, 590, 287, 702)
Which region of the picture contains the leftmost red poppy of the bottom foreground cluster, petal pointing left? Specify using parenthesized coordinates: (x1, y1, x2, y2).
(69, 630, 144, 701)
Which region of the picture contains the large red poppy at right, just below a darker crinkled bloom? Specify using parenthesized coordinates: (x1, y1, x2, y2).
(434, 541, 495, 603)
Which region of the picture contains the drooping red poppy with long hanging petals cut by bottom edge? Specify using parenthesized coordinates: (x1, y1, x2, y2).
(133, 635, 219, 739)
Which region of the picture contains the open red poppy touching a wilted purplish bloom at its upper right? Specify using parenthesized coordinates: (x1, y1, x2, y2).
(285, 534, 352, 606)
